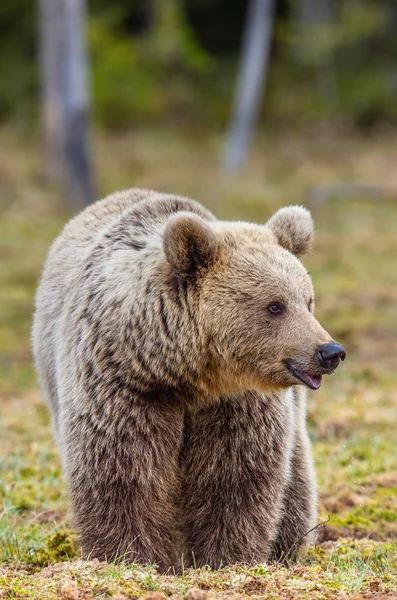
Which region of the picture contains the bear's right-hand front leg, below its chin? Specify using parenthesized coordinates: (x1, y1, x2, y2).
(180, 391, 293, 568)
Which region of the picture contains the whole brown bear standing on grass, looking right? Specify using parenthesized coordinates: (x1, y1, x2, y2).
(33, 190, 345, 569)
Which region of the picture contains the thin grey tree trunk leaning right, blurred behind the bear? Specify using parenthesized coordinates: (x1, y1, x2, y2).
(223, 0, 274, 173)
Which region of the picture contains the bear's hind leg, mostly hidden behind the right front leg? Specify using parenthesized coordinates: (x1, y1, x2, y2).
(270, 430, 317, 562)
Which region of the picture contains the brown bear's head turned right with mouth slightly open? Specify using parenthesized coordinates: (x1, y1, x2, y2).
(164, 206, 345, 393)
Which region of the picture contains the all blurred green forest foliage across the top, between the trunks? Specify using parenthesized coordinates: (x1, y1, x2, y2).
(0, 0, 397, 129)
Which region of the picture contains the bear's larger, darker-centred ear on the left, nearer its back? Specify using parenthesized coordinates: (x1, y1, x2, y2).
(163, 212, 219, 279)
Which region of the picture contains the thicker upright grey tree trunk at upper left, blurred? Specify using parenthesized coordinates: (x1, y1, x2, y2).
(40, 0, 93, 209)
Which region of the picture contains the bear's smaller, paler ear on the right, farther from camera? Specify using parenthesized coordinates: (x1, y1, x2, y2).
(267, 206, 314, 257)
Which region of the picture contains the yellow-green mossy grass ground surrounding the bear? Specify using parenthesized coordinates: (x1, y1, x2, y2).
(0, 124, 397, 600)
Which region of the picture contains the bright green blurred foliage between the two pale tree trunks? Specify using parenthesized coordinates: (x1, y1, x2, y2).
(89, 3, 226, 128)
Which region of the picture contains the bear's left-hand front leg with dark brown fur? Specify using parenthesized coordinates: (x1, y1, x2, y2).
(63, 390, 183, 570)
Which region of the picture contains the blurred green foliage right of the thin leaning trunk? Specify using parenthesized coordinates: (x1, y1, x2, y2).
(267, 0, 397, 127)
